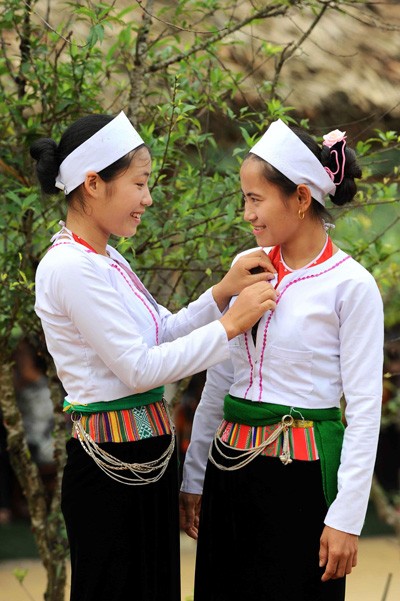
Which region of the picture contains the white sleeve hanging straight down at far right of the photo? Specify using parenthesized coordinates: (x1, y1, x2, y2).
(325, 274, 383, 534)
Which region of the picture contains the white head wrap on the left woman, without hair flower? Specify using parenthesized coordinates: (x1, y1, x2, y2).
(55, 111, 144, 195)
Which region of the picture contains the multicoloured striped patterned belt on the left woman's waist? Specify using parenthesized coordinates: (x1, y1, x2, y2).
(72, 401, 172, 442)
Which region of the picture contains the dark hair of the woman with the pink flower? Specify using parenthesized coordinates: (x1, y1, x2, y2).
(245, 126, 361, 219)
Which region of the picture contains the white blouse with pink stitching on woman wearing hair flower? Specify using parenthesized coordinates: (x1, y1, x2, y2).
(182, 245, 383, 534)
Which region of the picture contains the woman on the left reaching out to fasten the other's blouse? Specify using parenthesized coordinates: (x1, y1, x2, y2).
(31, 113, 276, 601)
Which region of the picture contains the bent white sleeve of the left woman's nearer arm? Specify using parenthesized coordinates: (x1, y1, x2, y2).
(36, 253, 229, 392)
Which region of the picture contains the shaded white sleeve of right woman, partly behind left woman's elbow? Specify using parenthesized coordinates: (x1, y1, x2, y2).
(181, 359, 233, 494)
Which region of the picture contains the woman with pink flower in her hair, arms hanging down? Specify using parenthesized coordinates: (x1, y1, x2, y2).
(181, 121, 383, 601)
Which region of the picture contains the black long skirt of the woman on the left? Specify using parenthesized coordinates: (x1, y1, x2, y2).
(62, 436, 181, 601)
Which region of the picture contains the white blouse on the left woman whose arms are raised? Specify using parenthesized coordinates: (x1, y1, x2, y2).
(35, 232, 229, 404)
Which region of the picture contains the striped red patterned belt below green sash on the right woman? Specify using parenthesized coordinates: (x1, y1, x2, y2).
(217, 420, 319, 461)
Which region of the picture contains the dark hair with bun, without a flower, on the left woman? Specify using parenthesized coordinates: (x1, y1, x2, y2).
(30, 115, 145, 200)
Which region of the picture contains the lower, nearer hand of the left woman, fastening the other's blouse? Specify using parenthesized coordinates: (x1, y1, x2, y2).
(220, 281, 276, 340)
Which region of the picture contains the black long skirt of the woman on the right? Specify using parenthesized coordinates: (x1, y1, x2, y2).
(194, 440, 345, 601)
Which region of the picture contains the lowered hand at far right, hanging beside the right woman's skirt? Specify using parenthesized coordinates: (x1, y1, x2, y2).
(319, 526, 358, 582)
